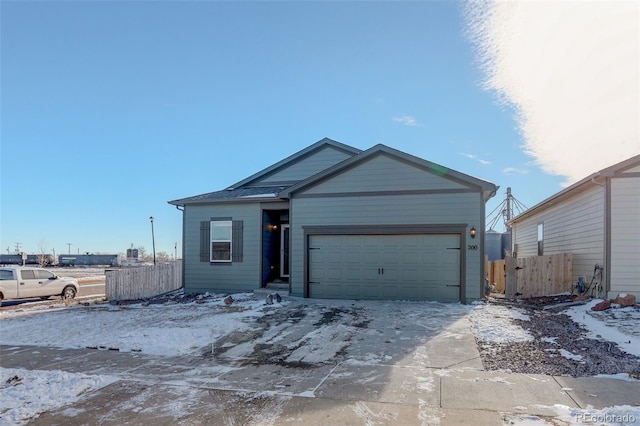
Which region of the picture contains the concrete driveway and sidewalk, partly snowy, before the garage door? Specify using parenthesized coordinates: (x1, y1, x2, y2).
(0, 299, 638, 425)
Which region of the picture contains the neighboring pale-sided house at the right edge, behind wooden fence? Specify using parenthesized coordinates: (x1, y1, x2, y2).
(510, 155, 640, 298)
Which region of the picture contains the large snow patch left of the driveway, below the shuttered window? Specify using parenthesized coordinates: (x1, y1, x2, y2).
(0, 295, 264, 356)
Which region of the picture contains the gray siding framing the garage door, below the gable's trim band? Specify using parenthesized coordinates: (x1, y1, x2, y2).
(291, 193, 482, 298)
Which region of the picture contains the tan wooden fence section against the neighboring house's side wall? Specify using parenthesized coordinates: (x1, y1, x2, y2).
(505, 253, 573, 299)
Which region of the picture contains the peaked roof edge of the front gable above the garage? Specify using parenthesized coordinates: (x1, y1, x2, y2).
(280, 144, 498, 201)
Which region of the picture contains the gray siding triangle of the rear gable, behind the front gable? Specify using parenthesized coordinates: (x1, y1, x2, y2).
(252, 146, 351, 186)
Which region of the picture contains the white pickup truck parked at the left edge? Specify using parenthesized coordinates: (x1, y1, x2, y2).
(0, 266, 80, 303)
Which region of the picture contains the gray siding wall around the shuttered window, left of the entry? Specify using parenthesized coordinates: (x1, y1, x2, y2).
(184, 203, 262, 293)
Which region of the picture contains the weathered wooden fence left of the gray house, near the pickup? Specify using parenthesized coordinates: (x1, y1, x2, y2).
(105, 260, 182, 300)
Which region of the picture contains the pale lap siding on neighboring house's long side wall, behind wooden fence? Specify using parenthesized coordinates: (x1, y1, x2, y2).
(512, 186, 605, 290)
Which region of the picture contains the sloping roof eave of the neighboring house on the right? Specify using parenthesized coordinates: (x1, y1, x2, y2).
(508, 155, 640, 224)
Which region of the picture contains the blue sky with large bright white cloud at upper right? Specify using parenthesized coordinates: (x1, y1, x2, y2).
(0, 1, 640, 254)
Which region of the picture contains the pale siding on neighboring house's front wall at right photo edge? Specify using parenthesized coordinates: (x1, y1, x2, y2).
(611, 177, 640, 295)
